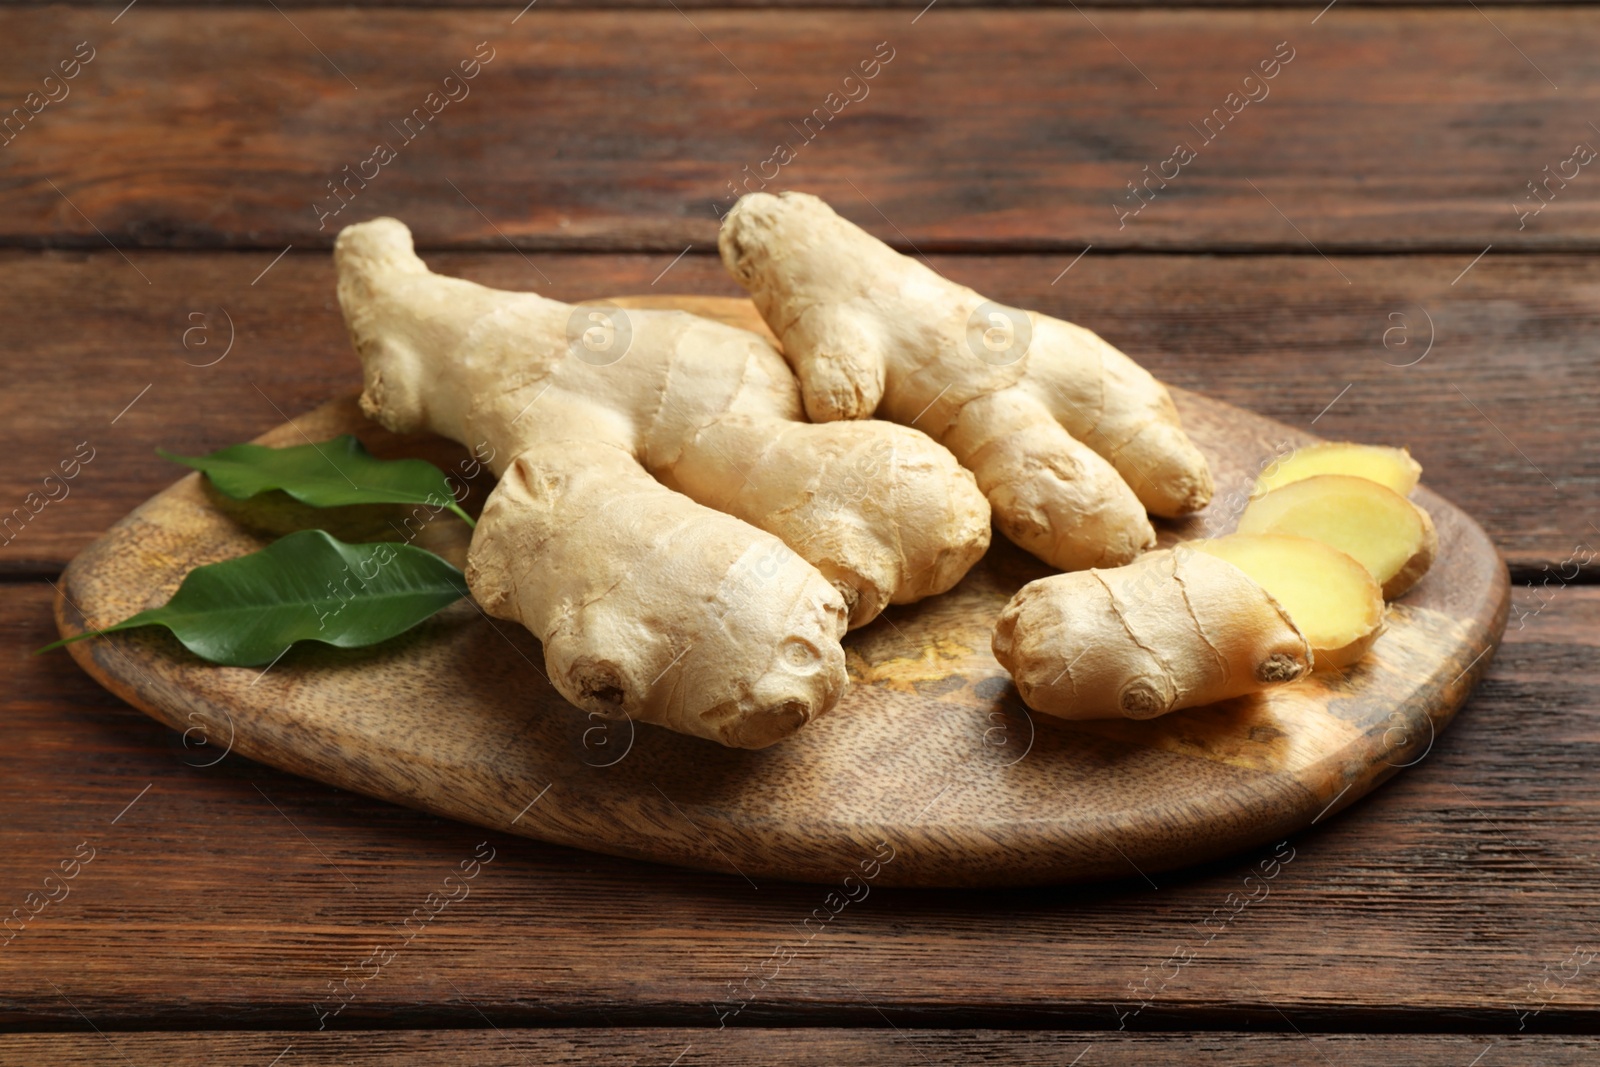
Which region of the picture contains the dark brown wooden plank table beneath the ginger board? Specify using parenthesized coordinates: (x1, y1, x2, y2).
(0, 0, 1600, 1067)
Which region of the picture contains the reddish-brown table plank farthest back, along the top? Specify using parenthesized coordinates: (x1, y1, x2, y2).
(0, 5, 1600, 254)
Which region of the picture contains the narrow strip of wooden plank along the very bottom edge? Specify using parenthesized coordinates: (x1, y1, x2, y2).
(0, 1029, 1600, 1067)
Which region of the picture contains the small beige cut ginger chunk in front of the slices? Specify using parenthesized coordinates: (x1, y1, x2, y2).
(994, 545, 1312, 718)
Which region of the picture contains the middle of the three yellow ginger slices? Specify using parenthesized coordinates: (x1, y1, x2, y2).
(1238, 474, 1438, 600)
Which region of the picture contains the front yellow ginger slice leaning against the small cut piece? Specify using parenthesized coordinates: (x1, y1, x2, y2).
(1189, 534, 1384, 669)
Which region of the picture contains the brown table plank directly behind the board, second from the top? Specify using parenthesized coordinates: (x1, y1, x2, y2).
(0, 250, 1600, 575)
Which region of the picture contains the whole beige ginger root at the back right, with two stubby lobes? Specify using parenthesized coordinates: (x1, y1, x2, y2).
(718, 192, 1211, 569)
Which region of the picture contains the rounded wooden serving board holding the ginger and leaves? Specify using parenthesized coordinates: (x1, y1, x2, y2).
(56, 298, 1509, 886)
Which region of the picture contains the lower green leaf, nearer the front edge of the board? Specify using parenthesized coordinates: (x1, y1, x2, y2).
(38, 530, 467, 667)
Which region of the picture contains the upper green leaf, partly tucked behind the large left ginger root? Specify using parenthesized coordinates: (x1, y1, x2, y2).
(155, 434, 475, 526)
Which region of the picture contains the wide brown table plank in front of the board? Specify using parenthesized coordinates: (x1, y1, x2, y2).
(0, 582, 1600, 1023)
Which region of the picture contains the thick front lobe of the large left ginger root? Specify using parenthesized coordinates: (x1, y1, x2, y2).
(467, 442, 848, 749)
